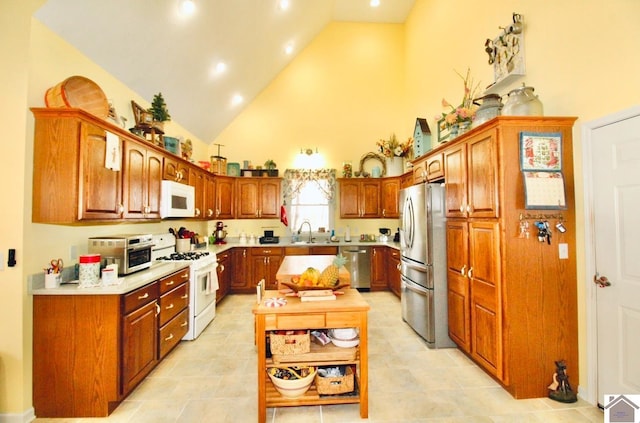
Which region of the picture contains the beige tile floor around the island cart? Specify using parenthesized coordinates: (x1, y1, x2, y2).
(35, 292, 603, 423)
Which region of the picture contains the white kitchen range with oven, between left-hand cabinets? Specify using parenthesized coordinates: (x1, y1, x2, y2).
(151, 234, 219, 341)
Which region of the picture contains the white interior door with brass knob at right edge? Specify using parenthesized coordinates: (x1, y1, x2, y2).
(585, 114, 640, 405)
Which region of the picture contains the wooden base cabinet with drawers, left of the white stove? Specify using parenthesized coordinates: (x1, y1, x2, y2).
(33, 267, 189, 418)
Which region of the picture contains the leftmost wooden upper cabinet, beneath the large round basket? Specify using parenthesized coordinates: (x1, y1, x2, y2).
(31, 108, 124, 224)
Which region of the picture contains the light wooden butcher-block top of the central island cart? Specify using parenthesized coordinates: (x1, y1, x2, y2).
(253, 288, 370, 314)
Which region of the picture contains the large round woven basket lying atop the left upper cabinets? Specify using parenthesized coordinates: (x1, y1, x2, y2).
(44, 75, 109, 119)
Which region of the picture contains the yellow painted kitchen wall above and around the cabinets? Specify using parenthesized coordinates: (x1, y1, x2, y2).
(0, 0, 640, 416)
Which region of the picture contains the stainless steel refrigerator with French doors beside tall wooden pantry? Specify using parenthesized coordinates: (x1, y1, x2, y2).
(400, 184, 455, 348)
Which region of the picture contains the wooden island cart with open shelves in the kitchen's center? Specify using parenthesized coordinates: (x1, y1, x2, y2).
(253, 289, 369, 423)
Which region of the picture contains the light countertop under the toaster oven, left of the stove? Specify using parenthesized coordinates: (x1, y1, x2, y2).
(29, 261, 190, 295)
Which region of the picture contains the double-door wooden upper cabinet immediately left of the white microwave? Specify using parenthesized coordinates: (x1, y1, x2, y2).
(122, 140, 162, 219)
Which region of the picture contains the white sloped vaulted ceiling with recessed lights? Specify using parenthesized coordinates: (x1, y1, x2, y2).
(35, 0, 415, 143)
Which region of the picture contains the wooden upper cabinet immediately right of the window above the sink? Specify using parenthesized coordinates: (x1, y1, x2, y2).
(338, 178, 381, 219)
